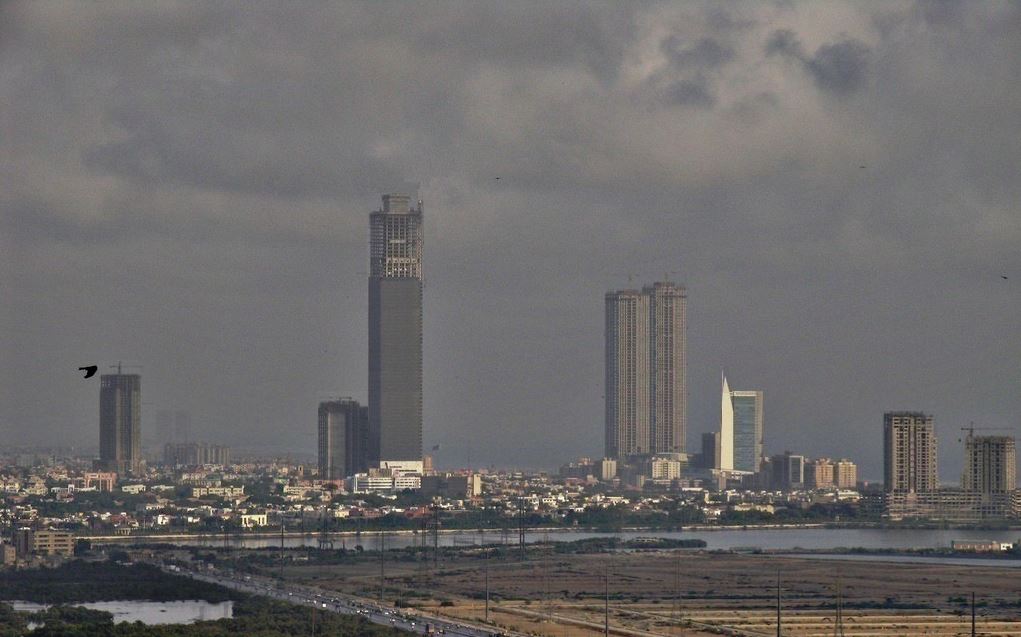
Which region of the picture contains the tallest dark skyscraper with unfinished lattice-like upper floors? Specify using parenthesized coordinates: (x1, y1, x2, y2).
(369, 195, 423, 464)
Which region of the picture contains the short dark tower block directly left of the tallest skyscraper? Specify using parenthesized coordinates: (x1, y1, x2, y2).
(319, 398, 369, 480)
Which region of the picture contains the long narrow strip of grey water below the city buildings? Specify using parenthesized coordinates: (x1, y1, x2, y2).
(115, 528, 1021, 550)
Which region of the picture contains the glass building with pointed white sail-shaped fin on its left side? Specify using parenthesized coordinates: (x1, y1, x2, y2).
(720, 376, 763, 473)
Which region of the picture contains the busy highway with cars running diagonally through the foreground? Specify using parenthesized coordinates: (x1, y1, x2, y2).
(161, 567, 527, 637)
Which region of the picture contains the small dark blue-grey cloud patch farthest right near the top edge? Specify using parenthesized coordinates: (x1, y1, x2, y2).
(766, 30, 870, 95)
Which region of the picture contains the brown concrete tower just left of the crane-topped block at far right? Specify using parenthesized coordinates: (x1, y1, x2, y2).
(883, 411, 939, 493)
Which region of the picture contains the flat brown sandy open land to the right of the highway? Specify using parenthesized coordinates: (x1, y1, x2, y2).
(253, 548, 1021, 637)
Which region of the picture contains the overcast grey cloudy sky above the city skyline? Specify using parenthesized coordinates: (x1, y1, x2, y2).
(0, 0, 1021, 480)
